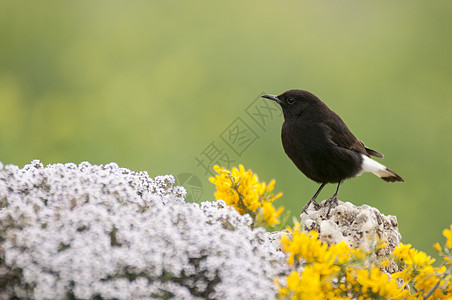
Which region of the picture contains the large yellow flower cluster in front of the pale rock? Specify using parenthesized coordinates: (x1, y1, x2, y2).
(278, 224, 452, 299)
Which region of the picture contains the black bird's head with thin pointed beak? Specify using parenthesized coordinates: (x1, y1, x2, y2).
(262, 90, 323, 120)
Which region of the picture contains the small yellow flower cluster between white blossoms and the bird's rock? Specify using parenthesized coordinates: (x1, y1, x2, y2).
(209, 165, 284, 227)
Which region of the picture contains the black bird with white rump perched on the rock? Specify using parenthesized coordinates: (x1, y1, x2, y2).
(262, 90, 404, 215)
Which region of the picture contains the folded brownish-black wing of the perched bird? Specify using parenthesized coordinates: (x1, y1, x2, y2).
(325, 112, 383, 158)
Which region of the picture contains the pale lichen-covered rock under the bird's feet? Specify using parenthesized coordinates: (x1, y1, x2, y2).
(300, 200, 402, 273)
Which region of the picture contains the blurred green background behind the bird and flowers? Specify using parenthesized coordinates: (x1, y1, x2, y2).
(0, 0, 452, 254)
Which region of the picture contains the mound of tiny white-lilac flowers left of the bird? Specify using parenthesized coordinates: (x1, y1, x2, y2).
(0, 160, 285, 299)
